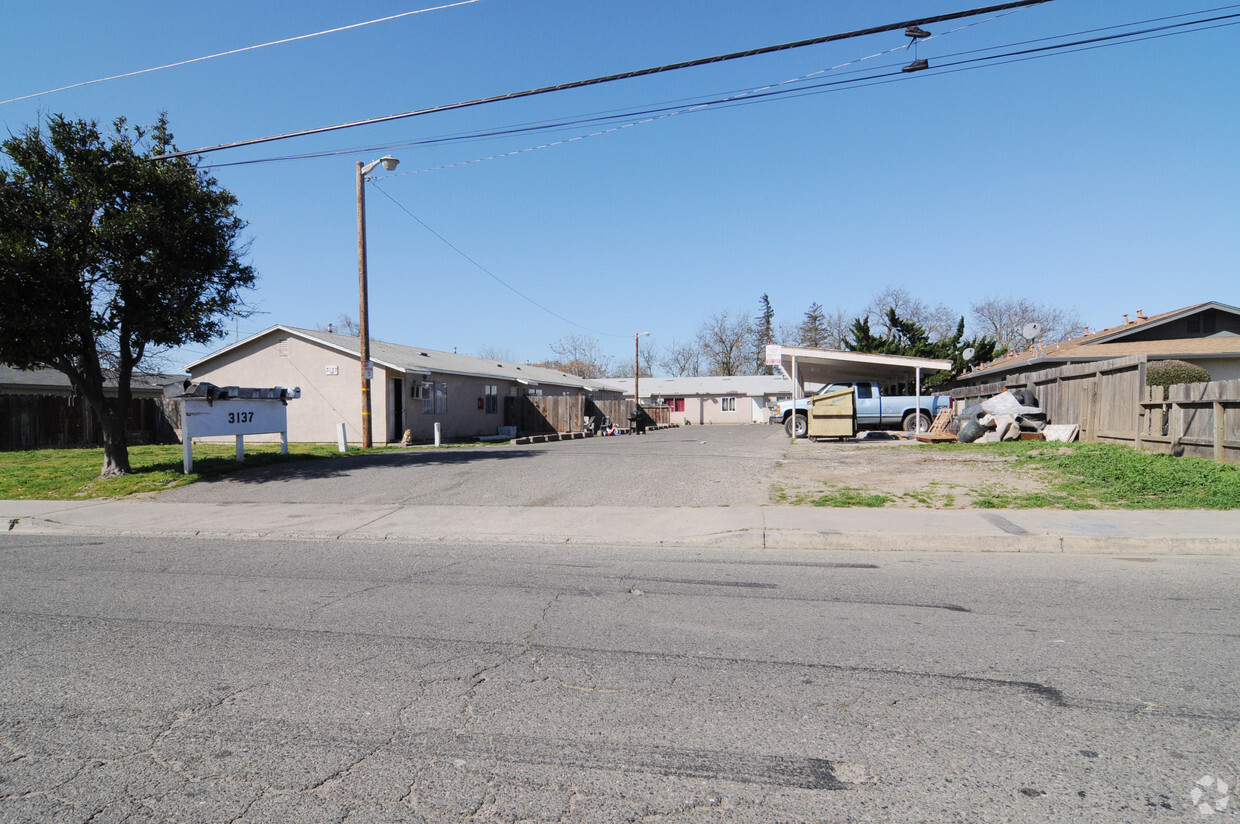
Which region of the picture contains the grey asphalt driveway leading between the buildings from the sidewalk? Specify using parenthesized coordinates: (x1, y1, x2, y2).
(159, 424, 789, 507)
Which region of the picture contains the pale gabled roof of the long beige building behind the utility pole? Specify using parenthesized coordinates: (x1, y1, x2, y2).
(186, 325, 613, 392)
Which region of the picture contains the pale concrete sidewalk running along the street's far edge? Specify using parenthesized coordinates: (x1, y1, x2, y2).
(0, 501, 1240, 554)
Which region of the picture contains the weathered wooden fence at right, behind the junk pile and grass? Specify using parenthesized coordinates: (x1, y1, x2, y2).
(950, 356, 1240, 462)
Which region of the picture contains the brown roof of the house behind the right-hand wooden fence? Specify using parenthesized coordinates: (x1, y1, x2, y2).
(960, 301, 1240, 382)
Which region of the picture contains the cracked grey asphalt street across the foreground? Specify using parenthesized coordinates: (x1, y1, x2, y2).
(0, 535, 1240, 824)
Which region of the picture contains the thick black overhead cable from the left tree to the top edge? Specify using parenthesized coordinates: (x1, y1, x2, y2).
(151, 0, 1052, 160)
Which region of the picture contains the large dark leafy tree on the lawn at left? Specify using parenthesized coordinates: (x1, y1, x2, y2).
(0, 115, 254, 476)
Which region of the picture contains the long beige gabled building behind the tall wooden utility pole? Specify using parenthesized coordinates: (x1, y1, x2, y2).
(186, 325, 620, 444)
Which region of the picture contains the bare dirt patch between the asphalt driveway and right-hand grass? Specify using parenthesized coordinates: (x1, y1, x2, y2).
(771, 440, 1049, 509)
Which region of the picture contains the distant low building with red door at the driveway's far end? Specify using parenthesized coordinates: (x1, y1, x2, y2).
(603, 374, 792, 424)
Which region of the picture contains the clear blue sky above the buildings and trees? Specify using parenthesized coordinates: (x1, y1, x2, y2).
(0, 0, 1240, 367)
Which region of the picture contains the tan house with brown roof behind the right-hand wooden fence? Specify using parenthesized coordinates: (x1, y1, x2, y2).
(956, 301, 1240, 385)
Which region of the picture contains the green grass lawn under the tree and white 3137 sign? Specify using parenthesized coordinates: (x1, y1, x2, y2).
(0, 444, 360, 501)
